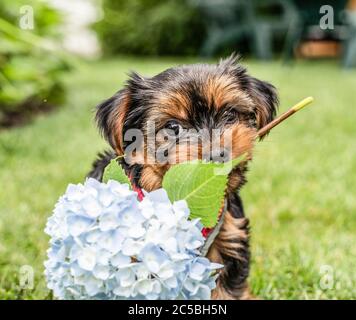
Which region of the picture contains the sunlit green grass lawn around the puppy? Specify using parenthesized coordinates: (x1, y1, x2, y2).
(0, 58, 356, 299)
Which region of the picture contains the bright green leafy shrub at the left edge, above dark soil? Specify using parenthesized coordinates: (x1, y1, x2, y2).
(0, 0, 68, 126)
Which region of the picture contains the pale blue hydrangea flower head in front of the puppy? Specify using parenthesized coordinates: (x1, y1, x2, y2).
(45, 178, 221, 299)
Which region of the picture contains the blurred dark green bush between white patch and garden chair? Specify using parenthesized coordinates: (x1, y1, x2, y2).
(96, 0, 205, 55)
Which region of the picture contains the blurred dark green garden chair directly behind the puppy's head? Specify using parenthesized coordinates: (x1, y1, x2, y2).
(190, 0, 297, 59)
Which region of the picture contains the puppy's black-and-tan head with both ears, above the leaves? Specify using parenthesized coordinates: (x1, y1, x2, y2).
(97, 57, 278, 191)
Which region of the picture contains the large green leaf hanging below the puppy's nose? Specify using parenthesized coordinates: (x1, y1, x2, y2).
(162, 157, 243, 228)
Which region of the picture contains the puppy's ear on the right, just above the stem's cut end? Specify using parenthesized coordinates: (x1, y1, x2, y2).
(248, 77, 279, 129)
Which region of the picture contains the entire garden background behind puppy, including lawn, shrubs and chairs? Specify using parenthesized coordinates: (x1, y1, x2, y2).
(0, 0, 356, 299)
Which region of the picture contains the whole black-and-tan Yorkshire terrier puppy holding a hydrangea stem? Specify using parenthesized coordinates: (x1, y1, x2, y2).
(89, 55, 278, 299)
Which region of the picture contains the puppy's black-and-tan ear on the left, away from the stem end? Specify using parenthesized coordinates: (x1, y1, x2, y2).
(95, 88, 131, 155)
